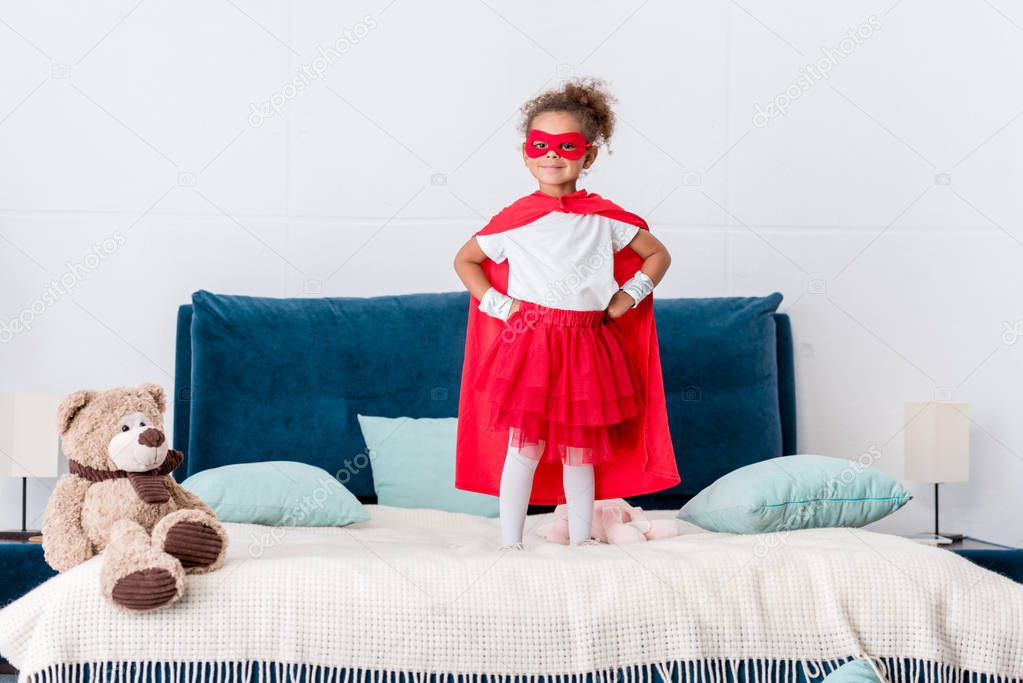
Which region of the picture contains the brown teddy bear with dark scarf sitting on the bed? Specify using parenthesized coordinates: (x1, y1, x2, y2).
(43, 383, 227, 611)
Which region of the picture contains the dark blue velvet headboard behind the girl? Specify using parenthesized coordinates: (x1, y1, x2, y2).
(174, 291, 796, 508)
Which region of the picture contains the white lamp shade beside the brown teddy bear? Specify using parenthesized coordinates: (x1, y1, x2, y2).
(0, 392, 60, 476)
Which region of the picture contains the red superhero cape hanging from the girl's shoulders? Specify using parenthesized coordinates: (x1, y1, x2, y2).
(454, 190, 680, 505)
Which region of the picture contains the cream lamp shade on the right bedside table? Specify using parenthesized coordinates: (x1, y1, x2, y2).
(904, 401, 970, 484)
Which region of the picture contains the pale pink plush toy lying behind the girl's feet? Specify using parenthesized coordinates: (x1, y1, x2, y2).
(536, 498, 678, 545)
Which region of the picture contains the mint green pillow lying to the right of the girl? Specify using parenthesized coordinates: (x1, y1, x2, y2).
(678, 455, 913, 534)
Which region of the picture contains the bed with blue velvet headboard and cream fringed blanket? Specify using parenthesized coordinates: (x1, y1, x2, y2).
(0, 292, 1023, 683)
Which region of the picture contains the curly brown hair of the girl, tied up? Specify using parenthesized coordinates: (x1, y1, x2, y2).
(519, 78, 618, 146)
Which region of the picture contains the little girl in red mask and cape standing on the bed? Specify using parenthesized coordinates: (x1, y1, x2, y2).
(454, 80, 679, 549)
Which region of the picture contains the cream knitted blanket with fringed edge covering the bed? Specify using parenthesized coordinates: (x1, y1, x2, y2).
(0, 506, 1023, 683)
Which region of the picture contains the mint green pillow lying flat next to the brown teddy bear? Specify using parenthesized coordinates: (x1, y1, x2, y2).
(181, 460, 369, 527)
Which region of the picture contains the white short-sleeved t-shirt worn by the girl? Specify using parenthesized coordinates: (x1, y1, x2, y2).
(476, 212, 639, 311)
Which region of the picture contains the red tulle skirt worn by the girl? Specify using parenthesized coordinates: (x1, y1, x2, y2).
(473, 301, 643, 465)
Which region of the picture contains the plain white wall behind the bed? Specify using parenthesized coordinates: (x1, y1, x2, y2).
(0, 0, 1023, 543)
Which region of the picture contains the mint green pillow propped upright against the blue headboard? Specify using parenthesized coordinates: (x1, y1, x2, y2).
(356, 414, 497, 517)
